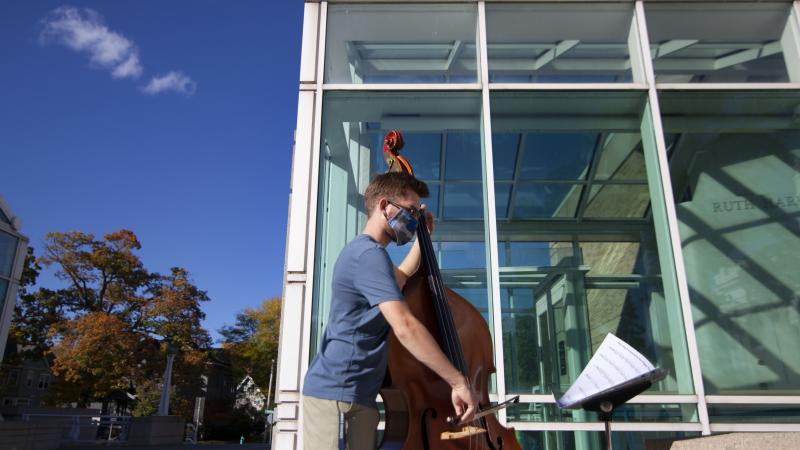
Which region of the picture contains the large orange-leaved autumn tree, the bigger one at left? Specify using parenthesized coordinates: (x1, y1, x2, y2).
(18, 230, 210, 416)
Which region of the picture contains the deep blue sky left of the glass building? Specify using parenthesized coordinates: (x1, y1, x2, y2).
(0, 0, 303, 337)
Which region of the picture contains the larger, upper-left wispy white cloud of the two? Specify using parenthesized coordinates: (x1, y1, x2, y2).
(39, 6, 142, 78)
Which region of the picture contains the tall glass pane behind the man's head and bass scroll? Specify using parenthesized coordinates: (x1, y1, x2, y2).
(312, 92, 491, 356)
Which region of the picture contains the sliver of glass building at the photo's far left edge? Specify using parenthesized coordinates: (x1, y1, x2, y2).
(0, 196, 28, 361)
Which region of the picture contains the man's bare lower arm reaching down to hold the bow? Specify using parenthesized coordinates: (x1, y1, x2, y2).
(378, 300, 478, 421)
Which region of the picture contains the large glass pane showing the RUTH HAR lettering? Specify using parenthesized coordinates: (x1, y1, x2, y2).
(660, 92, 800, 395)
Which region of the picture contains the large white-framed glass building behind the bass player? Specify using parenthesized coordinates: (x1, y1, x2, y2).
(273, 0, 800, 449)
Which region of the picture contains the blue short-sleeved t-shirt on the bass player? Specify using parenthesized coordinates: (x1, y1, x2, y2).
(303, 234, 403, 407)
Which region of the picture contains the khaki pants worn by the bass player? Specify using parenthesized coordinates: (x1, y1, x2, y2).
(303, 395, 380, 450)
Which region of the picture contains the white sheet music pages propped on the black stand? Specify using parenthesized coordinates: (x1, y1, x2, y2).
(557, 333, 656, 408)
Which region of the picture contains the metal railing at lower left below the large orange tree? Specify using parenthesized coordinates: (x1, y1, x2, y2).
(22, 414, 131, 443)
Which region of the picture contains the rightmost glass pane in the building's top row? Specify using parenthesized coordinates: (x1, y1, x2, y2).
(645, 2, 800, 83)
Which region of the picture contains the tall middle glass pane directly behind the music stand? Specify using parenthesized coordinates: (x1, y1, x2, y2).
(491, 92, 693, 404)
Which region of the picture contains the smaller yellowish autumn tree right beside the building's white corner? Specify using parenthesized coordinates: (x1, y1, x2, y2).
(219, 298, 281, 404)
